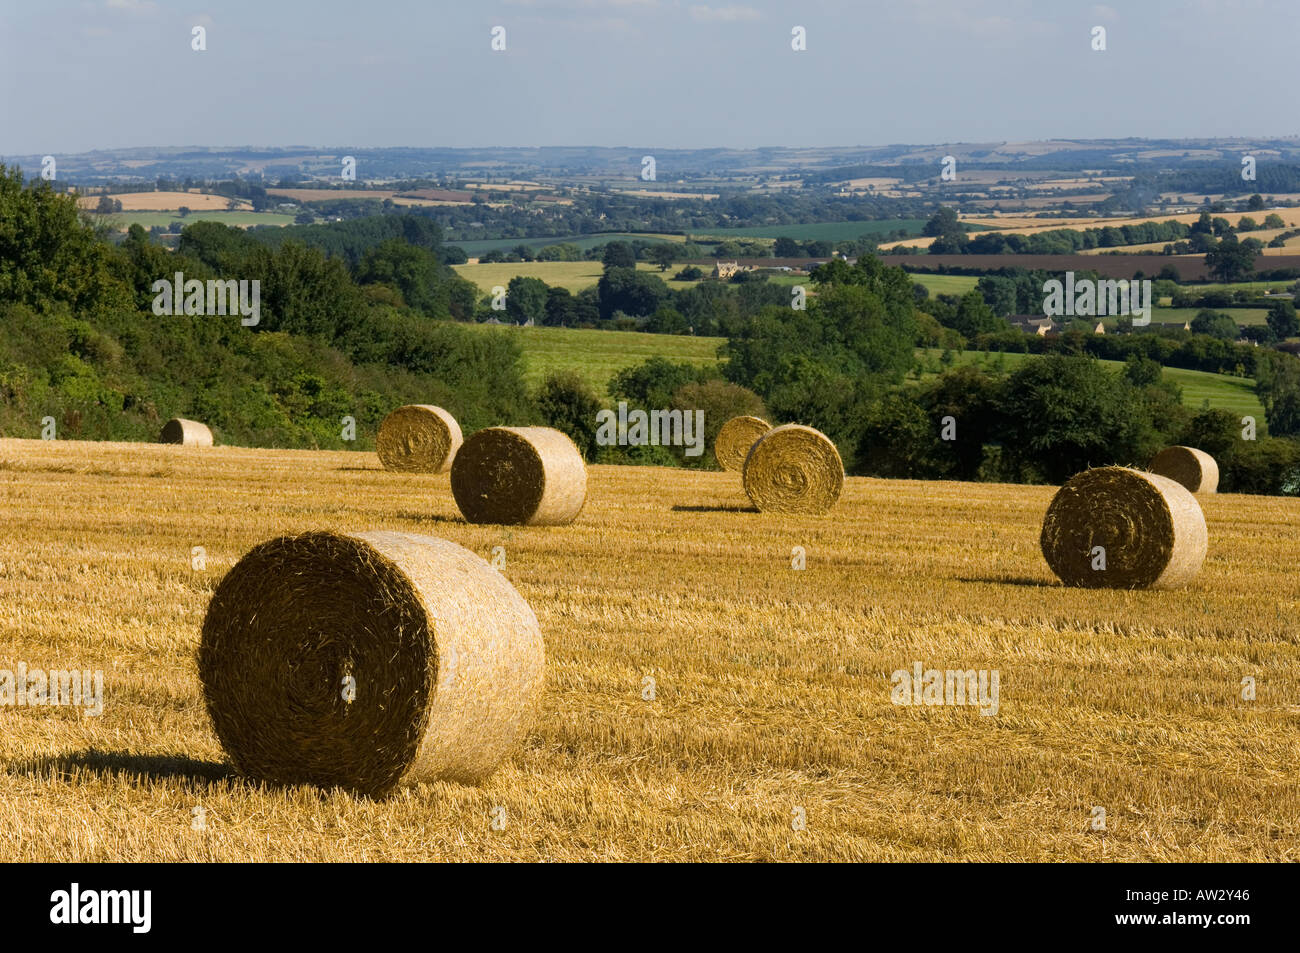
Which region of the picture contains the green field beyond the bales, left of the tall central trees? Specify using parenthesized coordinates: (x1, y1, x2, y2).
(469, 324, 725, 395)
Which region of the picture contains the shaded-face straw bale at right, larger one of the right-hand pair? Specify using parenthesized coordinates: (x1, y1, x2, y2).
(1040, 467, 1208, 589)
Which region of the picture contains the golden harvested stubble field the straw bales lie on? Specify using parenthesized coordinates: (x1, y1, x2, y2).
(0, 439, 1300, 862)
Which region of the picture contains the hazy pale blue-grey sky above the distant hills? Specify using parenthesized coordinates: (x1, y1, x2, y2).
(0, 0, 1300, 155)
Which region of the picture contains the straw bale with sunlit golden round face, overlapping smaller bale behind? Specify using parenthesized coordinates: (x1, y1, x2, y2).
(744, 424, 844, 516)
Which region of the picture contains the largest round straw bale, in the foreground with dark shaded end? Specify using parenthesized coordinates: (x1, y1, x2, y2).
(199, 532, 545, 797)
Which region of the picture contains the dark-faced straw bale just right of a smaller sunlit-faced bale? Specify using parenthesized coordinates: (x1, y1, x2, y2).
(451, 426, 586, 527)
